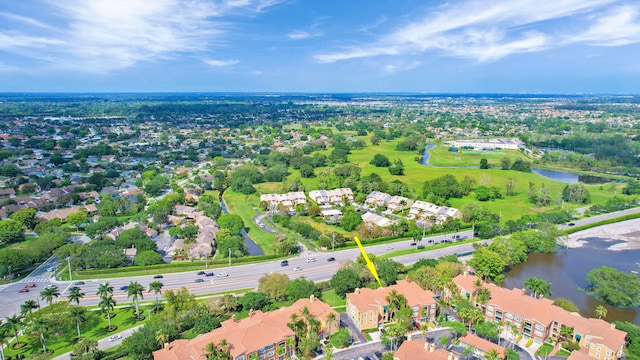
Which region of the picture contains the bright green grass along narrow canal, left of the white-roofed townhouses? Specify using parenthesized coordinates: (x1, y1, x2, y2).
(223, 189, 276, 254)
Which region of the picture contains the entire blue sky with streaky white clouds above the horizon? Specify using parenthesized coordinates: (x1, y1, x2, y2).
(0, 0, 640, 94)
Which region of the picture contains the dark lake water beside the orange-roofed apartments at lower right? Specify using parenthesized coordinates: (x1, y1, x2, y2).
(504, 238, 640, 324)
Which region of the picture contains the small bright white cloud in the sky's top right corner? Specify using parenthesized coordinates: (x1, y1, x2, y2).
(569, 6, 640, 46)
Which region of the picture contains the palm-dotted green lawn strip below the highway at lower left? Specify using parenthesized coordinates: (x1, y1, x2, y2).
(5, 306, 155, 357)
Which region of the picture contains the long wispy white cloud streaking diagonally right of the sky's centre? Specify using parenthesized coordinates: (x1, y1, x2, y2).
(315, 0, 624, 63)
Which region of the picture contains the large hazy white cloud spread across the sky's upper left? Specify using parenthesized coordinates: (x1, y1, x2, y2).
(0, 0, 279, 73)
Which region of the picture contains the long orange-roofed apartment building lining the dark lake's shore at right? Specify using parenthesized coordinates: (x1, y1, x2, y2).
(453, 273, 627, 360)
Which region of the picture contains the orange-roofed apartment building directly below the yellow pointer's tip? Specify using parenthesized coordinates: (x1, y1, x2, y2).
(347, 280, 436, 330)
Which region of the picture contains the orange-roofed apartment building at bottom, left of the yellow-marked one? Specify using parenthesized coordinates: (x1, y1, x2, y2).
(153, 296, 340, 360)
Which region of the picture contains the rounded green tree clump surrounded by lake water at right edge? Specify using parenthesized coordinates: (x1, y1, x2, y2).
(587, 266, 640, 308)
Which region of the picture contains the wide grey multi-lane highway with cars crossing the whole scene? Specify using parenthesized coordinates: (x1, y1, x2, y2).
(0, 208, 640, 318)
